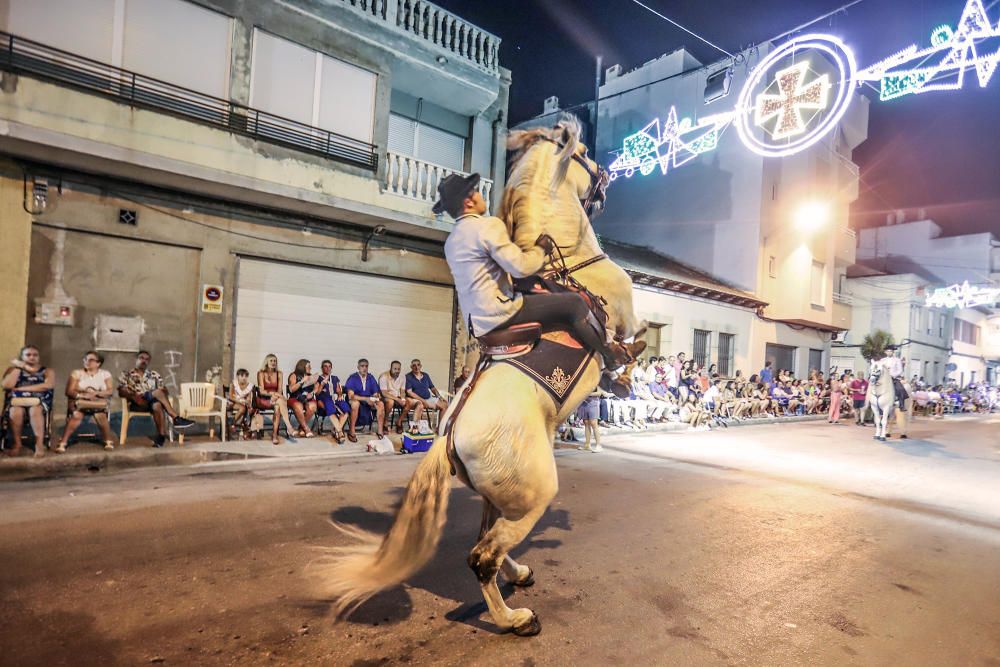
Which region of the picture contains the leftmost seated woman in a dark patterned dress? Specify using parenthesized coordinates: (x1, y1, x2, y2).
(3, 345, 56, 457)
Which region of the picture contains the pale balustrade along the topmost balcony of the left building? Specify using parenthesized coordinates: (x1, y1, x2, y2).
(341, 0, 500, 74)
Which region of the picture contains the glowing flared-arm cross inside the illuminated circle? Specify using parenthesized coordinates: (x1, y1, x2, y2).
(755, 61, 830, 140)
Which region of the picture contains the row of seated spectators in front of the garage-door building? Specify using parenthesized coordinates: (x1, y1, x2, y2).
(2, 345, 450, 456)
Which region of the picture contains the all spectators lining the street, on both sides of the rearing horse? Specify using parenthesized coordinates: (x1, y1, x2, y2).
(3, 345, 1000, 456)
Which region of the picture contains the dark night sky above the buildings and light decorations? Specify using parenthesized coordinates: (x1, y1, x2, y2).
(436, 0, 1000, 236)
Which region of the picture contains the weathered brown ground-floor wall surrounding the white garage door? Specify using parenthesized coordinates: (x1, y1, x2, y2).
(17, 182, 451, 417)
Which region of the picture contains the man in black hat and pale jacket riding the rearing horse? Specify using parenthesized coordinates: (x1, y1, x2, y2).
(433, 174, 629, 396)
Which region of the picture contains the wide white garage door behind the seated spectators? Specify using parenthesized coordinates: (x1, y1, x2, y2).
(233, 259, 454, 391)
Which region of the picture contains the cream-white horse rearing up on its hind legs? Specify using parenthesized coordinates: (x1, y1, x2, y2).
(309, 117, 640, 636)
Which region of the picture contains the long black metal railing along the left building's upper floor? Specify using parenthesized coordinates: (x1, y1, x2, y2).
(0, 31, 378, 171)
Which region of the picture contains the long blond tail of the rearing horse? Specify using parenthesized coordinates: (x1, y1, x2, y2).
(309, 437, 451, 615)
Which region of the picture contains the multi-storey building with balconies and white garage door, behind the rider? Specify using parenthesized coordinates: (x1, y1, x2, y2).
(0, 0, 510, 413)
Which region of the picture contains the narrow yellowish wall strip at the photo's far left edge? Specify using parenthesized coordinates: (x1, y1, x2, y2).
(0, 163, 31, 368)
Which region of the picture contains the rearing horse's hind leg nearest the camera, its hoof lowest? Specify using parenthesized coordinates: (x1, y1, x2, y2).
(469, 506, 551, 636)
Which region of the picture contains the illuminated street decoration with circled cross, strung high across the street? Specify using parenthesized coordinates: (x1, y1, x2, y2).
(608, 0, 1000, 180)
